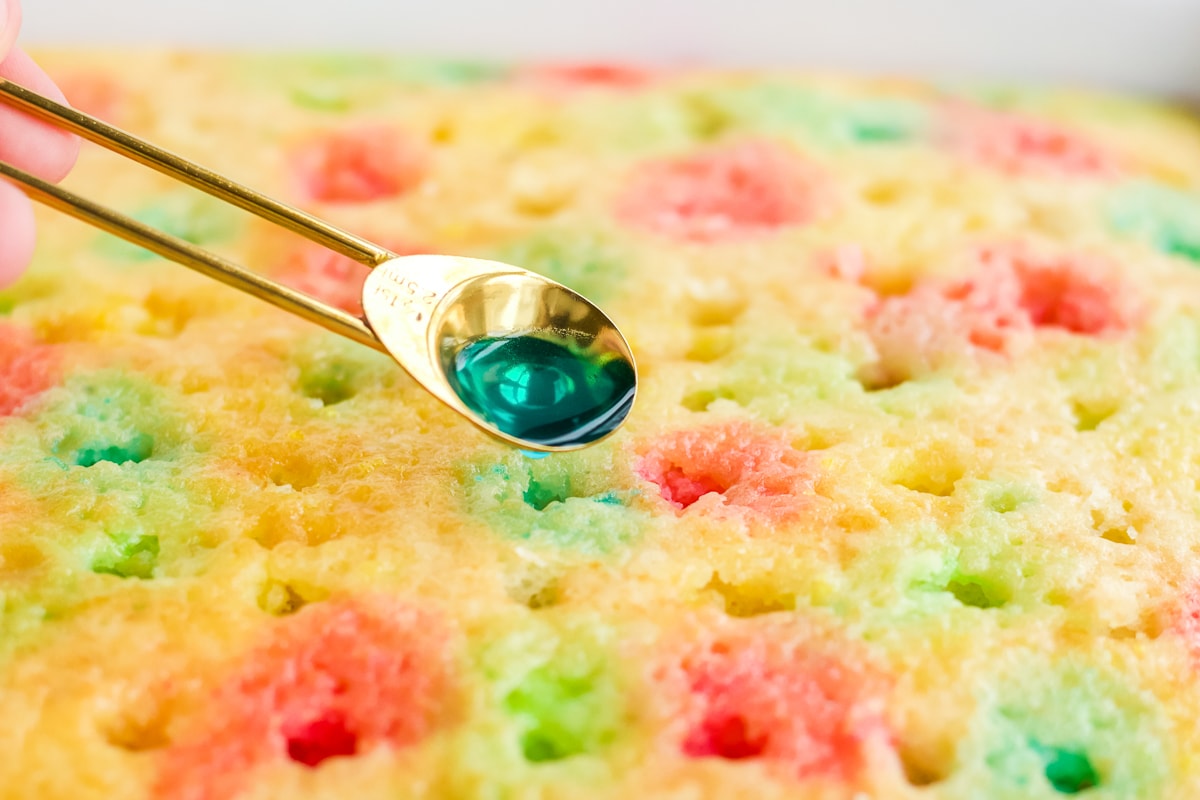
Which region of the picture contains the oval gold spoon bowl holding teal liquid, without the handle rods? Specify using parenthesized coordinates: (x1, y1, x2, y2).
(362, 255, 637, 452)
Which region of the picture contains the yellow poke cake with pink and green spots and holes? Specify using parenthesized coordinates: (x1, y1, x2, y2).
(0, 50, 1200, 800)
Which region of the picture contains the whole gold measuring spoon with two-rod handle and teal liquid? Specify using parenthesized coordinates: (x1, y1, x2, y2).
(0, 79, 637, 452)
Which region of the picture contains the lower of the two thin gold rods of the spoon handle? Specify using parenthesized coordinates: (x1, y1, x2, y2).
(0, 161, 386, 353)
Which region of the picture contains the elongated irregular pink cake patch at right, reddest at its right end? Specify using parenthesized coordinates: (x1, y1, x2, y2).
(868, 247, 1141, 379)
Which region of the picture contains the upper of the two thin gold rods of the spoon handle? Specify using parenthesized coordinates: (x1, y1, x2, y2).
(0, 79, 394, 267)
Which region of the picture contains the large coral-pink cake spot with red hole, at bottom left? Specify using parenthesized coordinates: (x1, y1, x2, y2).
(156, 602, 449, 800)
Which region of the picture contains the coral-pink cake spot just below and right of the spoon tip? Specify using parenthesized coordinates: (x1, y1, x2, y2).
(636, 422, 814, 522)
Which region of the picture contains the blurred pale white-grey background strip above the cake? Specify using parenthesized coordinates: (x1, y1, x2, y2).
(16, 0, 1200, 98)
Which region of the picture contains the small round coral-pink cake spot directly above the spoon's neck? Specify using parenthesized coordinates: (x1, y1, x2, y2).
(293, 127, 426, 203)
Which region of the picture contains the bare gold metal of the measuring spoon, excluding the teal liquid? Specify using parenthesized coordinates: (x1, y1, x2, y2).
(0, 79, 636, 452)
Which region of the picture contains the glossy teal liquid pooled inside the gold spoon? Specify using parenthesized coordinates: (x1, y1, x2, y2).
(445, 332, 637, 446)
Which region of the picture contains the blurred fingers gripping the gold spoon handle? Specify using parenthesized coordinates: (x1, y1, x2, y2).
(0, 0, 79, 287)
